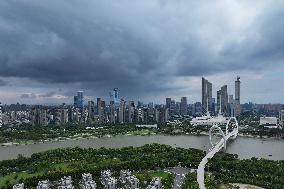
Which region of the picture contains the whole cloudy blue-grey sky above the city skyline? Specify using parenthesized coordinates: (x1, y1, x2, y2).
(0, 0, 284, 104)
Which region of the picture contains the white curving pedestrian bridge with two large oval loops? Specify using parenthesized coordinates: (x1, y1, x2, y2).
(197, 117, 239, 189)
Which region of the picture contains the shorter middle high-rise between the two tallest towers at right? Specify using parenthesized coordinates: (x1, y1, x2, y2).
(217, 85, 229, 115)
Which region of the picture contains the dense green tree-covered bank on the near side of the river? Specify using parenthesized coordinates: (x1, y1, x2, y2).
(0, 143, 284, 189)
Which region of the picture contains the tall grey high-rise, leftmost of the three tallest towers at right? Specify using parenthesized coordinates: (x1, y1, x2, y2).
(202, 77, 212, 112)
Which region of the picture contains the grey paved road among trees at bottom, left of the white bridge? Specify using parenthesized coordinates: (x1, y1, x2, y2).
(165, 167, 190, 189)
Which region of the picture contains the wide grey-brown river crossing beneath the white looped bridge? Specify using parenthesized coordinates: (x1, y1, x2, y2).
(0, 135, 284, 160)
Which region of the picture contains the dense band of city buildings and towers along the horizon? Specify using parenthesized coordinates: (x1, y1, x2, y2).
(0, 77, 284, 129)
